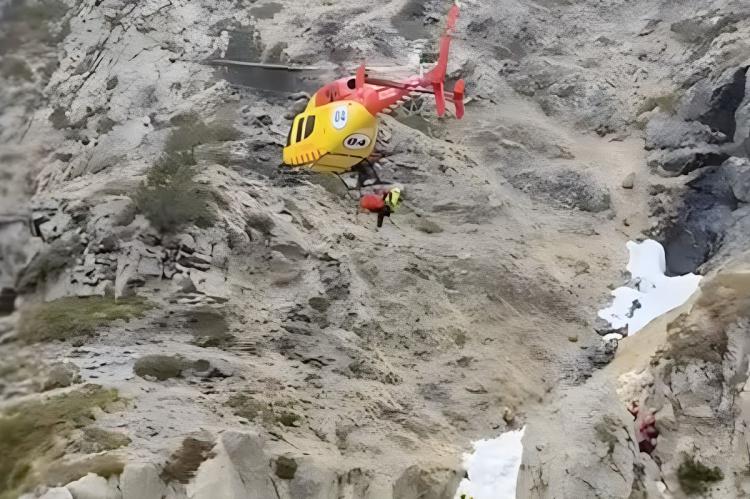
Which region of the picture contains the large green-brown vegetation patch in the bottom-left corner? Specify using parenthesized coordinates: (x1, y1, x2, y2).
(0, 385, 118, 499)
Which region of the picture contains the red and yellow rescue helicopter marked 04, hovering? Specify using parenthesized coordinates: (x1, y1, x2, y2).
(283, 4, 464, 174)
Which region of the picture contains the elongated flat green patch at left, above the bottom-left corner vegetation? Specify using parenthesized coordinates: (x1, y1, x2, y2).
(18, 296, 153, 343)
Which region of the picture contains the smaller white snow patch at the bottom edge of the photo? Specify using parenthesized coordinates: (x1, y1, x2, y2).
(454, 427, 526, 499)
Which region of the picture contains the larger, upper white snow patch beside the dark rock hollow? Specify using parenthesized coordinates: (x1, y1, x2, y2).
(599, 239, 701, 335)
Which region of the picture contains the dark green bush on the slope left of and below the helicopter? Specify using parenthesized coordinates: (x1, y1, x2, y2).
(133, 152, 217, 233)
